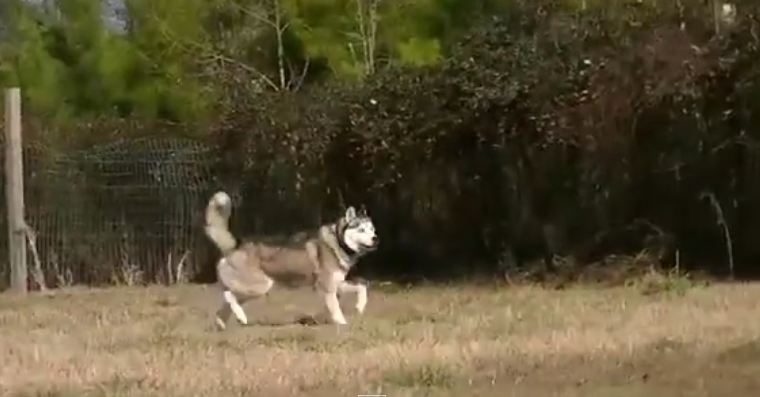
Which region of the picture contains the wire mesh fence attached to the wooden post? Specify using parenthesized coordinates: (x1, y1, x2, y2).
(0, 138, 220, 287)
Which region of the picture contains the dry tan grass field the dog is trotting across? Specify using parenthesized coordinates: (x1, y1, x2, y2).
(0, 276, 760, 397)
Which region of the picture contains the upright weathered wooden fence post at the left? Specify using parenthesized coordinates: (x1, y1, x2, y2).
(5, 88, 28, 294)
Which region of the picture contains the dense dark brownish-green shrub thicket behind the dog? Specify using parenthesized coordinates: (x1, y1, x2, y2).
(4, 0, 760, 276)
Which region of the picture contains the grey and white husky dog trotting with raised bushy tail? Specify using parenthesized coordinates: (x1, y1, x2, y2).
(204, 191, 380, 330)
